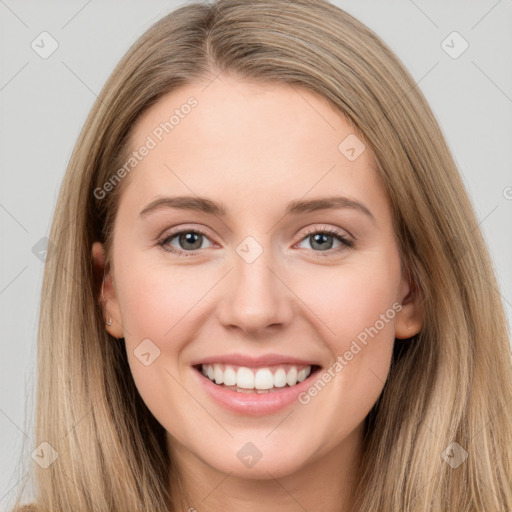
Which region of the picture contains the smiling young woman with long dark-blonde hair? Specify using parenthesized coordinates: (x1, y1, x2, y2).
(12, 0, 512, 512)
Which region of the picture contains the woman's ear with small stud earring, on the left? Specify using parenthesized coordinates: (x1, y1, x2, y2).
(92, 242, 124, 338)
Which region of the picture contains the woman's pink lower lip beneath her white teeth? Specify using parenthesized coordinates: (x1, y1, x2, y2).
(193, 367, 319, 416)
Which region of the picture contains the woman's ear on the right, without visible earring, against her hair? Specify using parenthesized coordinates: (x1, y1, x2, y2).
(395, 272, 425, 339)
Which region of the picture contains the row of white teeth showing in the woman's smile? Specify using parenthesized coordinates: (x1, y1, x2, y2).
(201, 363, 311, 393)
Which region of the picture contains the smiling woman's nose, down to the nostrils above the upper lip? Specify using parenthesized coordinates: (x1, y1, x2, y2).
(218, 249, 293, 337)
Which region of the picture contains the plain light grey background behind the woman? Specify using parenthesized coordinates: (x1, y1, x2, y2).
(0, 0, 512, 510)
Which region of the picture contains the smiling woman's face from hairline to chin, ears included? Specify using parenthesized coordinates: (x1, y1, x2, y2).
(93, 74, 421, 478)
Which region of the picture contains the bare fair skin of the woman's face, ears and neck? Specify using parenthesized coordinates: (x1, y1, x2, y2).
(92, 75, 423, 512)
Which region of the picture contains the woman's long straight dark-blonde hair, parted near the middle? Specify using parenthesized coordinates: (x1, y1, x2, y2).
(12, 0, 512, 512)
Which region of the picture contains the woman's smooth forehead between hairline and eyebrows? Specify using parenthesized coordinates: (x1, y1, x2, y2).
(118, 77, 383, 217)
